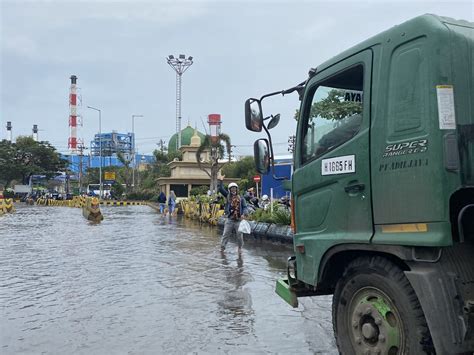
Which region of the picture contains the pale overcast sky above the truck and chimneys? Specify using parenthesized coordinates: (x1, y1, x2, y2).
(0, 0, 474, 156)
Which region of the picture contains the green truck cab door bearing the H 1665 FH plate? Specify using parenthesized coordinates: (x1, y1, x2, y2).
(292, 50, 373, 285)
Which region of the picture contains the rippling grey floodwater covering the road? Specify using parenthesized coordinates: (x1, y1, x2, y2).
(0, 206, 337, 354)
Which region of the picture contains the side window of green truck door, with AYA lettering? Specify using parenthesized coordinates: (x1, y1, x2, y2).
(302, 65, 364, 163)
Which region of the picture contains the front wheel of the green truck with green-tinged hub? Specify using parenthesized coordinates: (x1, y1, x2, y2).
(332, 256, 434, 355)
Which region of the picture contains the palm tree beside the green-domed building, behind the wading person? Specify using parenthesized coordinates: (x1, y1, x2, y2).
(196, 133, 231, 194)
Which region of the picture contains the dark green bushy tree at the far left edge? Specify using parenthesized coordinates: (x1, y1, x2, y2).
(0, 137, 67, 186)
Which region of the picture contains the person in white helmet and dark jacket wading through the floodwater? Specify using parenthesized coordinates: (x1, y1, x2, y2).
(219, 176, 247, 254)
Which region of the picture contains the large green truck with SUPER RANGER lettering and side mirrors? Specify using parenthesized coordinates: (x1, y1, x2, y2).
(245, 15, 474, 355)
